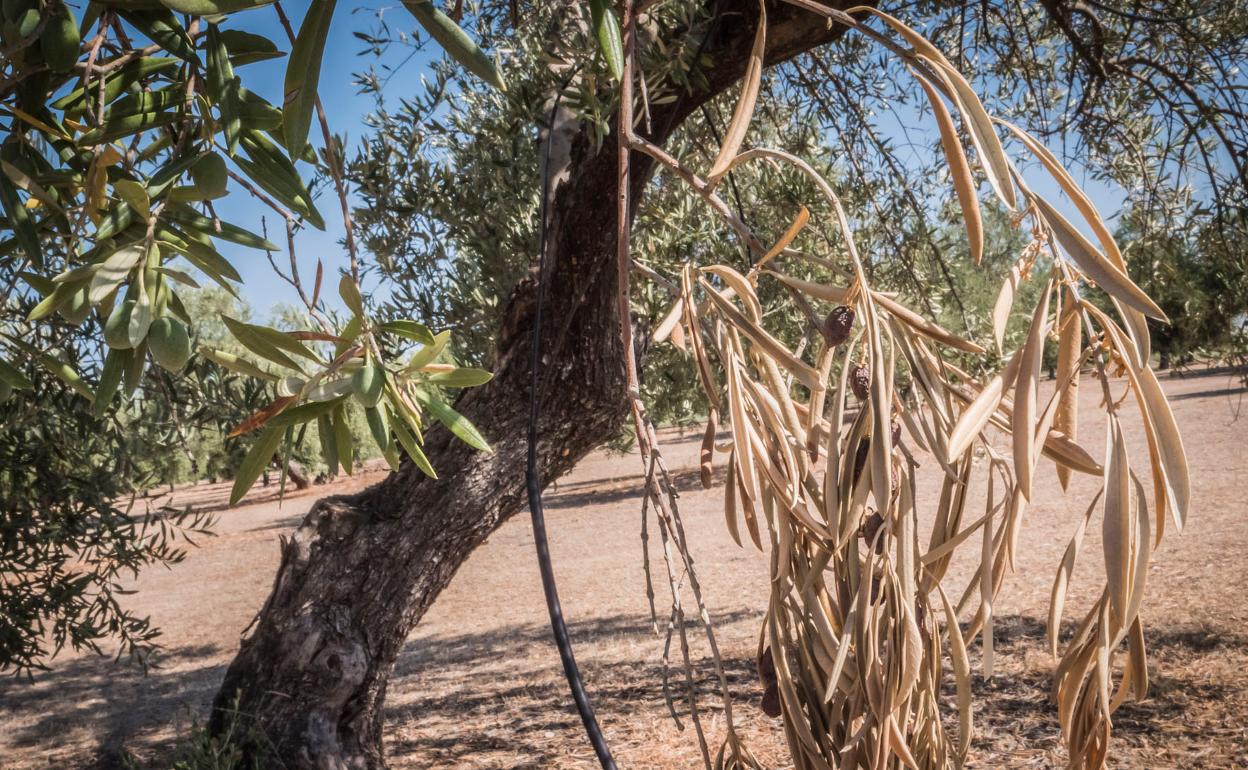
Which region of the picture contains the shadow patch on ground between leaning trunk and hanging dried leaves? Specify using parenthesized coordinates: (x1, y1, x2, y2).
(387, 610, 761, 769)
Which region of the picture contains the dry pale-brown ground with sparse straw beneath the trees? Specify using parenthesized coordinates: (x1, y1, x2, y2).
(0, 366, 1248, 770)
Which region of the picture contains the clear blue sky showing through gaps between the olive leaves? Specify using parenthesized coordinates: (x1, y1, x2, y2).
(217, 0, 1124, 319)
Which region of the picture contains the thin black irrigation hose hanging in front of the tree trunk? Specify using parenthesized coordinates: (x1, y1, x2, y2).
(524, 82, 615, 770)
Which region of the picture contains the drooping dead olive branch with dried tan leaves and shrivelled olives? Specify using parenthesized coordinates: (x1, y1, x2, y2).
(619, 0, 1191, 769)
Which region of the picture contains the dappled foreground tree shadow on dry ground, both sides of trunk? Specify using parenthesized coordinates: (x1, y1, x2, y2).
(0, 610, 1248, 770)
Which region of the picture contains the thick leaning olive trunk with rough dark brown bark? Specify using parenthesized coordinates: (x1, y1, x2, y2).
(211, 0, 863, 770)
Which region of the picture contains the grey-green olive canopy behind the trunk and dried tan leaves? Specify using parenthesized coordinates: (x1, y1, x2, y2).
(348, 2, 1248, 419)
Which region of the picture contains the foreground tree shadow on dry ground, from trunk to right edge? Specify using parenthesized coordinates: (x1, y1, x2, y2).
(388, 613, 1248, 769)
